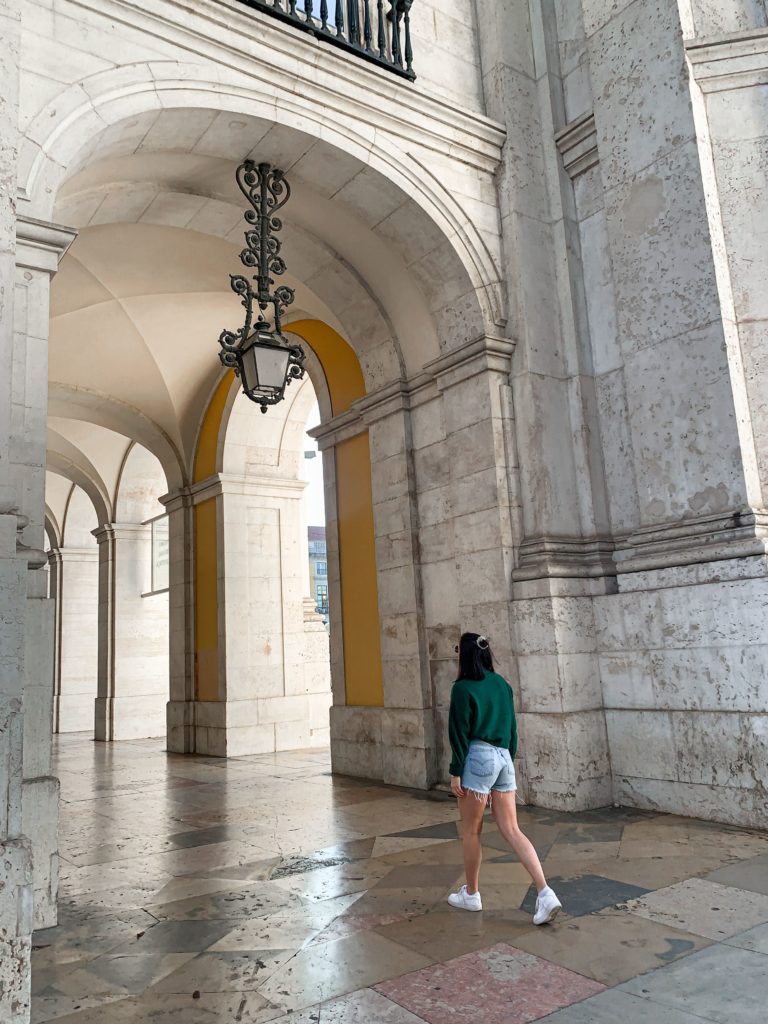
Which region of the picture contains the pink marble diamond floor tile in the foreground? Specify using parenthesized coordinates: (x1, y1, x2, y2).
(375, 943, 605, 1024)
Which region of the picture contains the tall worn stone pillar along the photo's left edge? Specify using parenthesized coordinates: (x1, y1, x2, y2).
(0, 25, 73, 999)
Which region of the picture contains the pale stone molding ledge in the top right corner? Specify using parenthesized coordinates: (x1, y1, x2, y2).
(685, 29, 768, 93)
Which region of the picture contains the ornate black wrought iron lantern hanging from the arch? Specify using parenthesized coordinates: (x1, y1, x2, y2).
(219, 160, 305, 413)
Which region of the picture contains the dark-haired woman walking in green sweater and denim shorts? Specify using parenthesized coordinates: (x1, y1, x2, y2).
(449, 633, 562, 925)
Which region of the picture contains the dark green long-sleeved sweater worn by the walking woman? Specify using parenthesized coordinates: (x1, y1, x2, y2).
(449, 672, 517, 776)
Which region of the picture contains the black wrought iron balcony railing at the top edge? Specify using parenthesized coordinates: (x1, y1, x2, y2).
(240, 0, 416, 81)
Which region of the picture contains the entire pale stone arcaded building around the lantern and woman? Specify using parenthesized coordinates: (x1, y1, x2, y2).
(0, 0, 768, 1024)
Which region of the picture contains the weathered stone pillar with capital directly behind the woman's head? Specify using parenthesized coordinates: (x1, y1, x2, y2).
(412, 338, 520, 781)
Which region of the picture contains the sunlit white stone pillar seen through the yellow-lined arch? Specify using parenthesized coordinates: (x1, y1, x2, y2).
(194, 474, 331, 756)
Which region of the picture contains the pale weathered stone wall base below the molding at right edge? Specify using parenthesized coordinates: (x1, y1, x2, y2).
(595, 555, 768, 828)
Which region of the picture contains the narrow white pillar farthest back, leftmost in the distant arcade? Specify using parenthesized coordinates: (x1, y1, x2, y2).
(48, 544, 99, 732)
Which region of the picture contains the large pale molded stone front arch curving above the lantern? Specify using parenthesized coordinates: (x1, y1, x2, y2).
(19, 61, 505, 360)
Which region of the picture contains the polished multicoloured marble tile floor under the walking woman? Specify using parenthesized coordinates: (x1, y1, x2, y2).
(33, 735, 768, 1024)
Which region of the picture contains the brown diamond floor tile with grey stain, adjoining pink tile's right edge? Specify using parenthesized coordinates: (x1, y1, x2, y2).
(515, 910, 710, 986)
